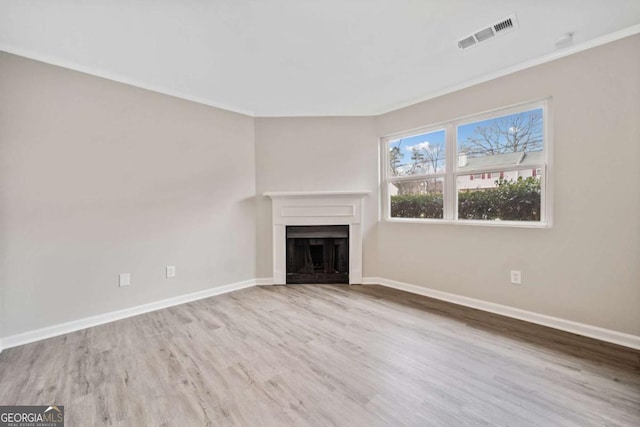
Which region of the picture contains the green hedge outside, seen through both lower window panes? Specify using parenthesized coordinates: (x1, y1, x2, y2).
(391, 177, 541, 221)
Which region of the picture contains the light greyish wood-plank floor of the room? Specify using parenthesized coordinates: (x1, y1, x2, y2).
(0, 285, 640, 426)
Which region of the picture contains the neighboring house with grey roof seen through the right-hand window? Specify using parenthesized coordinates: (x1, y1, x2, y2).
(457, 151, 543, 190)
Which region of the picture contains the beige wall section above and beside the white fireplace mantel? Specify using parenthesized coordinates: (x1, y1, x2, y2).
(255, 117, 379, 278)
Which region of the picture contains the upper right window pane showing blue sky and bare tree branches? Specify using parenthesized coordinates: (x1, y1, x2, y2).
(457, 108, 544, 171)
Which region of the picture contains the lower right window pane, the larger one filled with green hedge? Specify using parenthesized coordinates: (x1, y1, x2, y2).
(456, 172, 542, 221)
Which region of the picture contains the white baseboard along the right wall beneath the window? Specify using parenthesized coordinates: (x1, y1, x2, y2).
(362, 277, 640, 350)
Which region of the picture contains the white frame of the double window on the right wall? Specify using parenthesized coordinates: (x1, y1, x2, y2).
(380, 98, 553, 228)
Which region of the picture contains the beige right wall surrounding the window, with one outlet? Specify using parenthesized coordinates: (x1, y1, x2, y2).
(376, 36, 640, 335)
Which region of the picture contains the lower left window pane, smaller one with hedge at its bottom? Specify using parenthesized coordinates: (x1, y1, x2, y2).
(389, 178, 444, 218)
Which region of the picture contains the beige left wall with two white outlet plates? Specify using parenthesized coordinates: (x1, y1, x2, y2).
(0, 53, 255, 336)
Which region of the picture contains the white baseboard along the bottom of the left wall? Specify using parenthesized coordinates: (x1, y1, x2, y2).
(0, 279, 258, 351)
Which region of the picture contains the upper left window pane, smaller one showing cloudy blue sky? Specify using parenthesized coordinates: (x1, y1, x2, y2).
(389, 130, 445, 176)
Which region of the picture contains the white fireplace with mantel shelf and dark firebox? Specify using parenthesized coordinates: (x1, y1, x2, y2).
(264, 190, 370, 285)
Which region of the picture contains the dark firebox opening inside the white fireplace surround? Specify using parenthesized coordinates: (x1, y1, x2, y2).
(287, 225, 349, 284)
